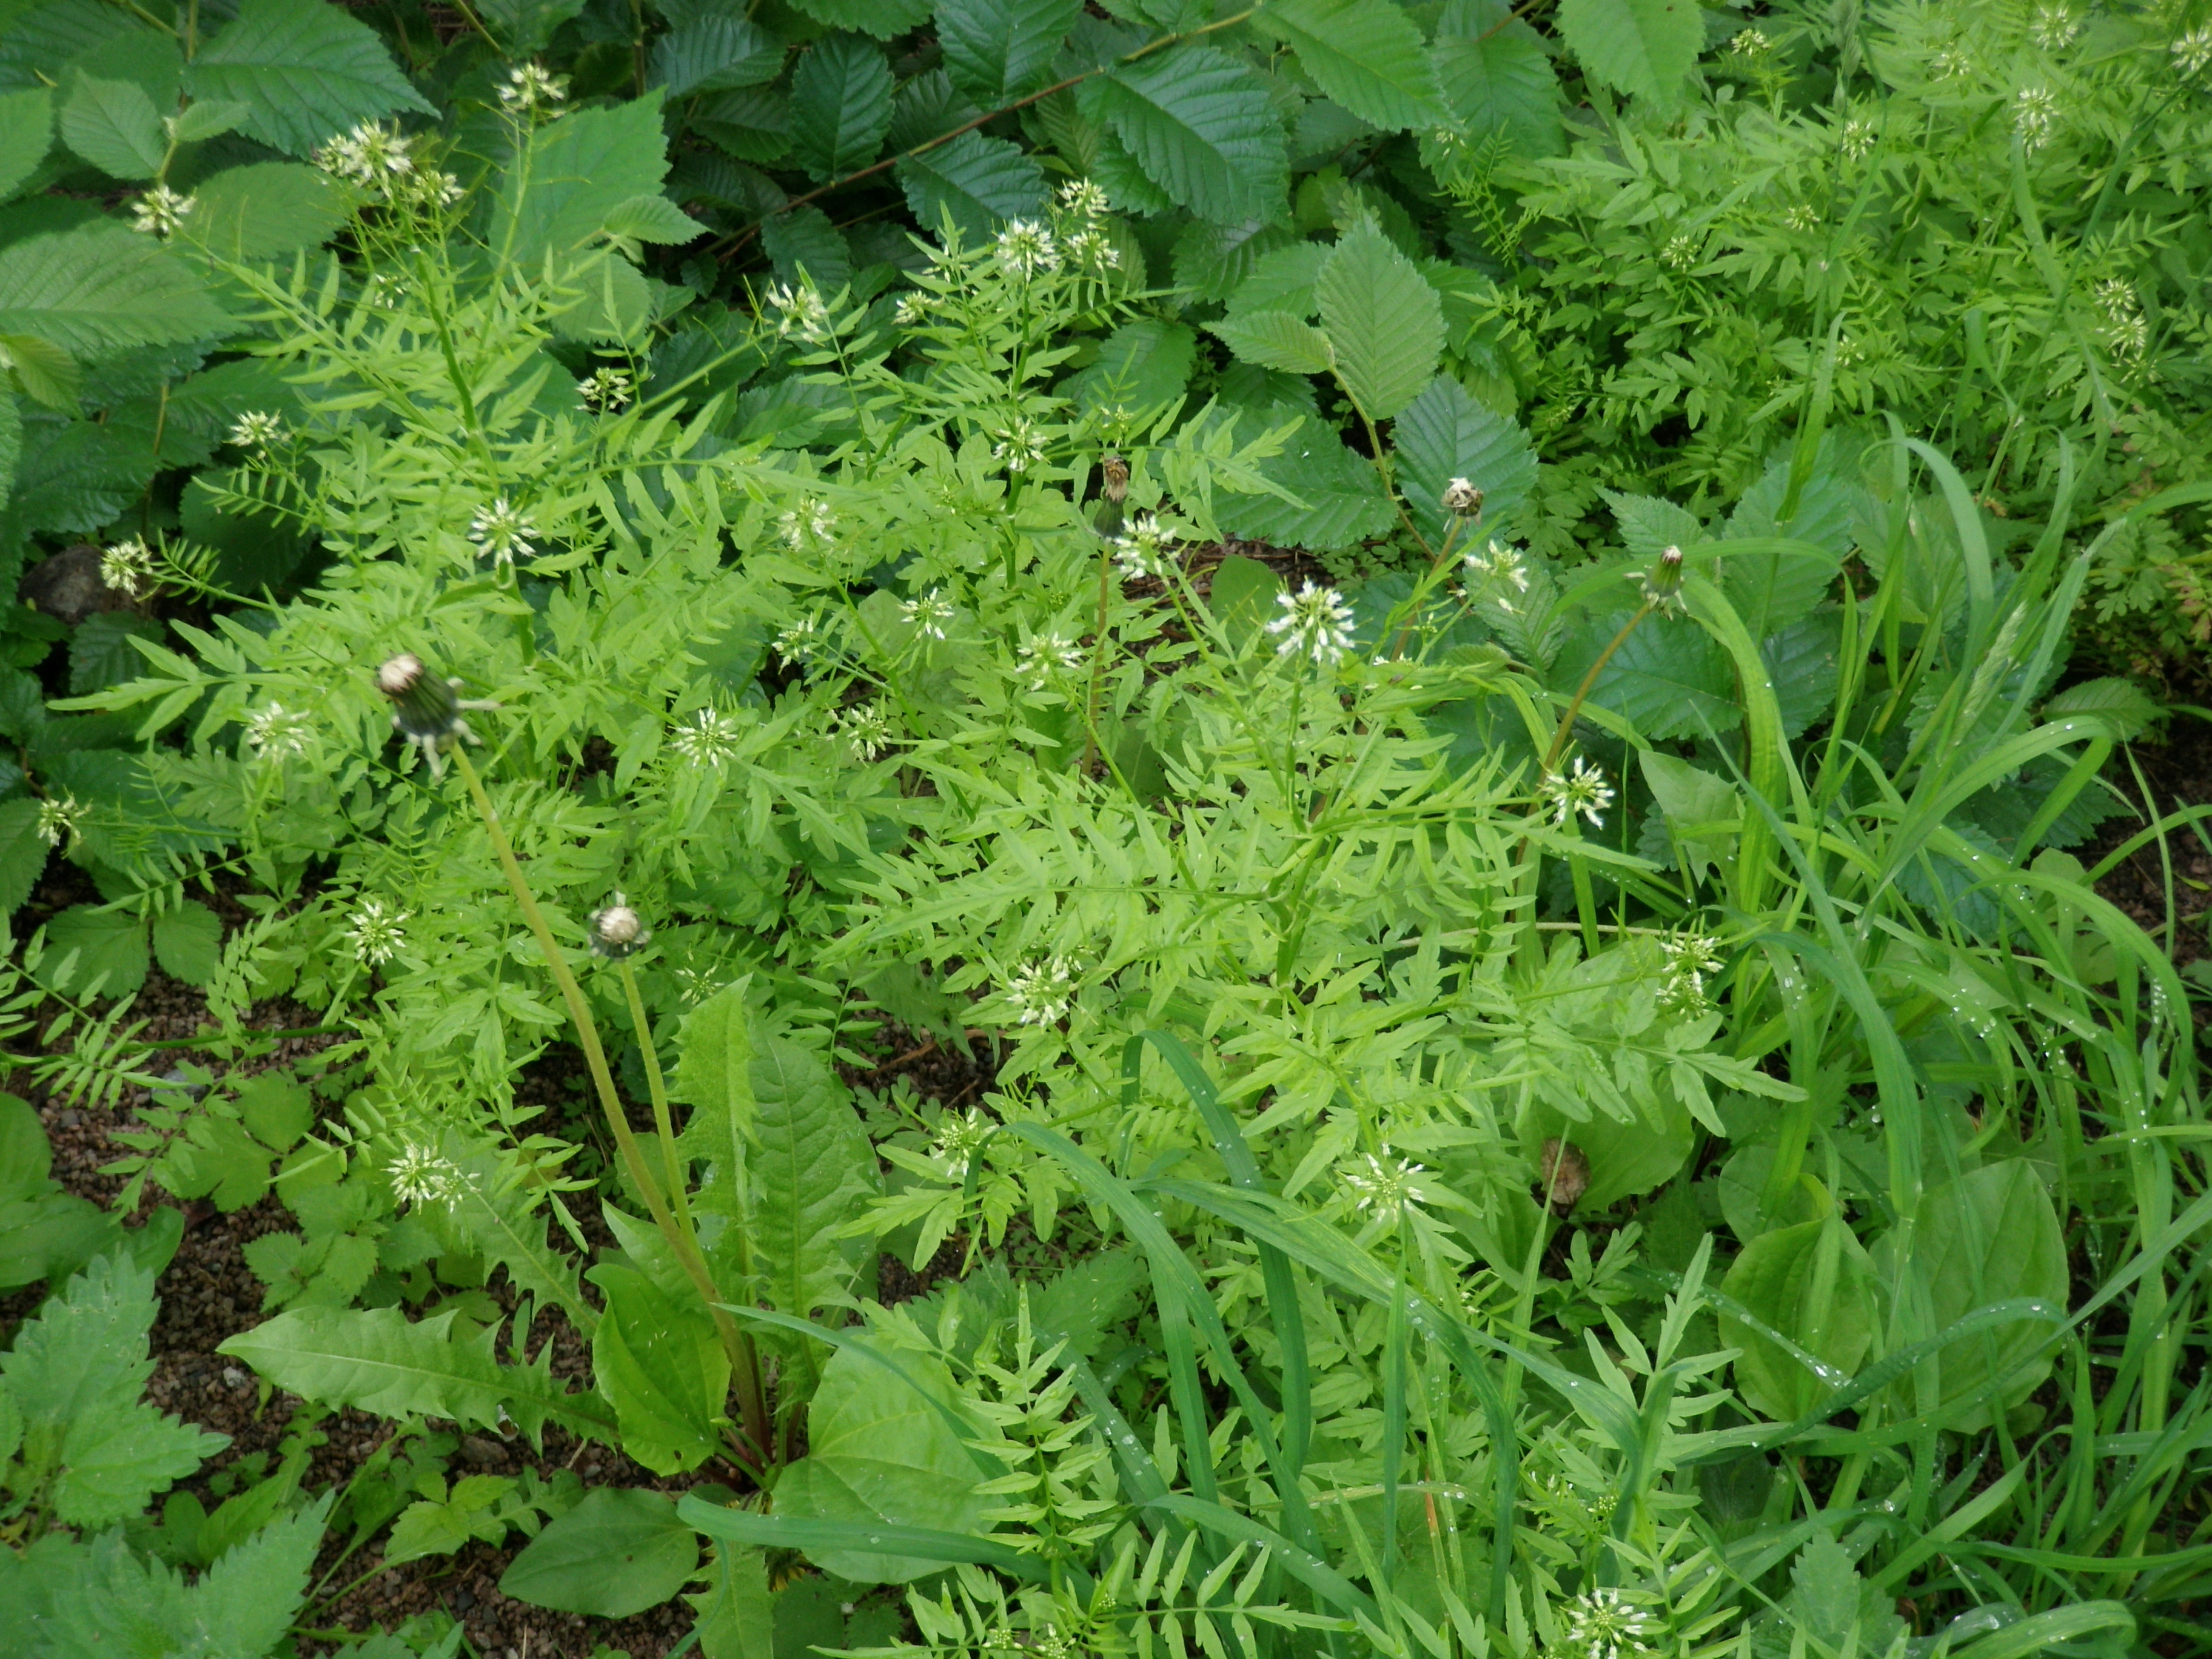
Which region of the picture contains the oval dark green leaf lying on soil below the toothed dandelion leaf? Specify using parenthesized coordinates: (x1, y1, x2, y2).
(500, 1486, 699, 1619)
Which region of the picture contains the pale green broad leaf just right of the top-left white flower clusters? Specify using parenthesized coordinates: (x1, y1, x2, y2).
(491, 91, 668, 270)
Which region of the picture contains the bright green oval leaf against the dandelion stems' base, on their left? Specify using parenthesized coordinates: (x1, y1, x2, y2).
(591, 1263, 730, 1475)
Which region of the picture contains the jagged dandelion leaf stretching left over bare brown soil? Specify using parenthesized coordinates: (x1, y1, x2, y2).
(217, 1307, 615, 1444)
